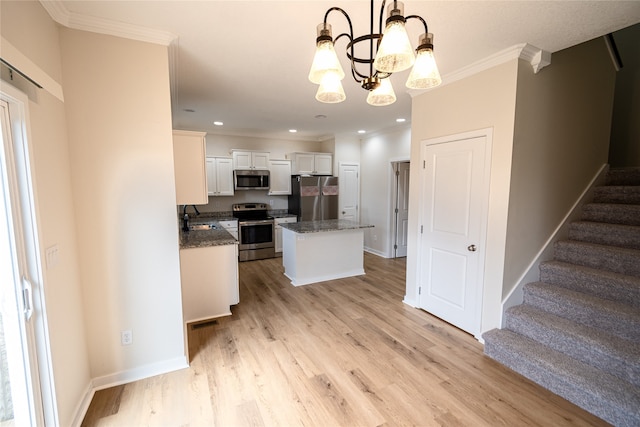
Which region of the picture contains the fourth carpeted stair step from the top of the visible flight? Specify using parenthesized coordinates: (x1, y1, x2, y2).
(569, 222, 640, 249)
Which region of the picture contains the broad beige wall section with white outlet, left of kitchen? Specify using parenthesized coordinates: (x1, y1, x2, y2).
(60, 28, 185, 385)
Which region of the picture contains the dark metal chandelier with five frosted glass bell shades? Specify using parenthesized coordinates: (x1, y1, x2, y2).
(309, 0, 442, 106)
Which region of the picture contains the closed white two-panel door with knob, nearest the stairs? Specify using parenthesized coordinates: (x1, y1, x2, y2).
(418, 135, 489, 335)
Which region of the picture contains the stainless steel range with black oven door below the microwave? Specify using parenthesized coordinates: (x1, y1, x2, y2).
(232, 203, 275, 261)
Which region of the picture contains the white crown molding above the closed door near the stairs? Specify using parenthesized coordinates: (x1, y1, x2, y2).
(409, 43, 551, 97)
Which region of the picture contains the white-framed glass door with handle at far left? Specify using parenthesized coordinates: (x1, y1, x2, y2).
(0, 87, 52, 426)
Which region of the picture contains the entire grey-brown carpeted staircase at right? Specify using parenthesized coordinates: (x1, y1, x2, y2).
(483, 168, 640, 426)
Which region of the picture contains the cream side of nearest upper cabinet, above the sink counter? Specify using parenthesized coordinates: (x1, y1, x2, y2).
(173, 130, 209, 205)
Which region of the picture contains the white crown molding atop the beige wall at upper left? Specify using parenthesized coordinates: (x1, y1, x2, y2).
(40, 0, 178, 46)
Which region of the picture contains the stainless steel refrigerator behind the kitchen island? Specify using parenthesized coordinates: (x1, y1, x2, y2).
(289, 175, 338, 221)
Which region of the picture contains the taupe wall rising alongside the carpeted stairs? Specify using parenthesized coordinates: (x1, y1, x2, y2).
(502, 38, 615, 297)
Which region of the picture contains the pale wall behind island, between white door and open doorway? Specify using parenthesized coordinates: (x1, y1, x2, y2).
(360, 127, 411, 258)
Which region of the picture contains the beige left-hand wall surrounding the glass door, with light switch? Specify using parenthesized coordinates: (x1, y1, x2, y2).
(0, 1, 91, 426)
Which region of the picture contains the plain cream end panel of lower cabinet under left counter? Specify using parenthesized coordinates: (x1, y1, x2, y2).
(180, 245, 239, 323)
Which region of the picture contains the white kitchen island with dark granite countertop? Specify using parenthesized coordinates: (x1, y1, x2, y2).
(281, 219, 373, 286)
